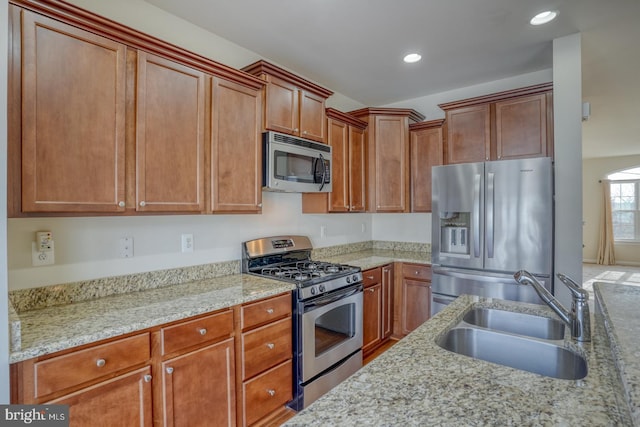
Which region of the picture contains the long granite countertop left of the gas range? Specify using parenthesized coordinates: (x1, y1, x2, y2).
(9, 274, 294, 363)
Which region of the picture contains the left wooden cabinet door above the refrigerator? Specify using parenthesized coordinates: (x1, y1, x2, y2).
(445, 104, 491, 164)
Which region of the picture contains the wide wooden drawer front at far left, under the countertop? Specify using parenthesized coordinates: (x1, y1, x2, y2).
(34, 333, 151, 397)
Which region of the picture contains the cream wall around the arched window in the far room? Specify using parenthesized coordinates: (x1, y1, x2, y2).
(582, 155, 640, 265)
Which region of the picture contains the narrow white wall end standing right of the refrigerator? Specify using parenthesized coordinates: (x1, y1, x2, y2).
(553, 34, 582, 306)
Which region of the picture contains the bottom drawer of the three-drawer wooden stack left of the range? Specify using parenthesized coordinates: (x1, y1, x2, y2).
(242, 360, 293, 425)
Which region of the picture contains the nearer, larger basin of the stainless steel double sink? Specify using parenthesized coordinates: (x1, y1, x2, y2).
(438, 327, 587, 380)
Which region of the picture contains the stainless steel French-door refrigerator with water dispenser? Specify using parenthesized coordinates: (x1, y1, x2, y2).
(431, 157, 552, 314)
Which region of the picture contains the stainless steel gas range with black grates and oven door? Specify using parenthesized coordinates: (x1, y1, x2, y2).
(242, 236, 362, 410)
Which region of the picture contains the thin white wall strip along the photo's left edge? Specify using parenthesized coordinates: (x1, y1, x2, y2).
(0, 1, 9, 404)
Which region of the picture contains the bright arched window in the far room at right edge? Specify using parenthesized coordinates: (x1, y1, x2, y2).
(607, 167, 640, 242)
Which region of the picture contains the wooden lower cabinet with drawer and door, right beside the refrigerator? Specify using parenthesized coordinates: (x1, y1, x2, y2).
(399, 263, 431, 335)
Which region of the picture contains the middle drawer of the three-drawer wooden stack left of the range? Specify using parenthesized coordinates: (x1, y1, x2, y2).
(242, 317, 293, 379)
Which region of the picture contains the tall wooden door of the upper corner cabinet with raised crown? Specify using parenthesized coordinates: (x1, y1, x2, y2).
(374, 116, 409, 212)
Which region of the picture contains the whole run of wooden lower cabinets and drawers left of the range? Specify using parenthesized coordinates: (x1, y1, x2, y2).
(10, 293, 293, 427)
